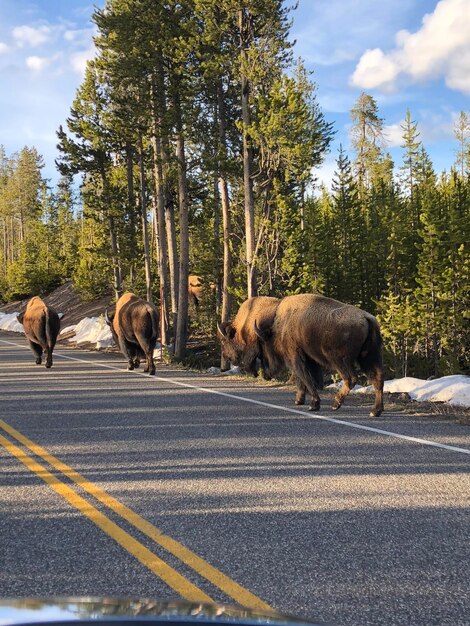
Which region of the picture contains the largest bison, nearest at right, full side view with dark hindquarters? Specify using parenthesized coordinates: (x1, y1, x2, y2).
(254, 294, 384, 417)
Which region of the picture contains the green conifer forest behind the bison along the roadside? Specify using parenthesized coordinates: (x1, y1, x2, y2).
(0, 0, 470, 377)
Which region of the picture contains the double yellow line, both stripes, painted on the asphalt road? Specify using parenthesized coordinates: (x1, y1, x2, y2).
(0, 420, 271, 610)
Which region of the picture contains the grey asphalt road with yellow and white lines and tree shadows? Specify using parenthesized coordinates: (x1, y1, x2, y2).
(0, 333, 470, 626)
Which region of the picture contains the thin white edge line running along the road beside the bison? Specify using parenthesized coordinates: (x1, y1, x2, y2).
(0, 339, 470, 455)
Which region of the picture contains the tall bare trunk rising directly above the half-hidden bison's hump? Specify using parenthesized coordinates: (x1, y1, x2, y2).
(238, 9, 258, 298)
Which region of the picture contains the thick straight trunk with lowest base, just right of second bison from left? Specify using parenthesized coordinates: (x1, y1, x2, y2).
(175, 101, 189, 359)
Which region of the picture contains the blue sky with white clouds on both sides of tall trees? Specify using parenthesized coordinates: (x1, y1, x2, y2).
(0, 0, 470, 183)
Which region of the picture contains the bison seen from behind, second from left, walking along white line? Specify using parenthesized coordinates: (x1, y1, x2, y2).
(105, 292, 159, 374)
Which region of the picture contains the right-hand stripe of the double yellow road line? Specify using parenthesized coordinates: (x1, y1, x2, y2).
(0, 420, 272, 611)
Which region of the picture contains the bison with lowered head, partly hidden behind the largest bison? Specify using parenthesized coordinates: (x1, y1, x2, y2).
(217, 296, 280, 376)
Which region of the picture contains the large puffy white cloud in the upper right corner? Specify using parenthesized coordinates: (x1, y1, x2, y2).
(351, 0, 470, 94)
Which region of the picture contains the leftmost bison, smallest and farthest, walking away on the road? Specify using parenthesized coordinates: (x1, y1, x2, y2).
(17, 296, 60, 368)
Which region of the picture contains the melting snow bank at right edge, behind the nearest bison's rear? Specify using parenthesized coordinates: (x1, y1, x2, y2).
(329, 374, 470, 409)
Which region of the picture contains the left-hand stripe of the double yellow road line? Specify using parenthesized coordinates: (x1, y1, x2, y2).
(0, 432, 212, 602)
